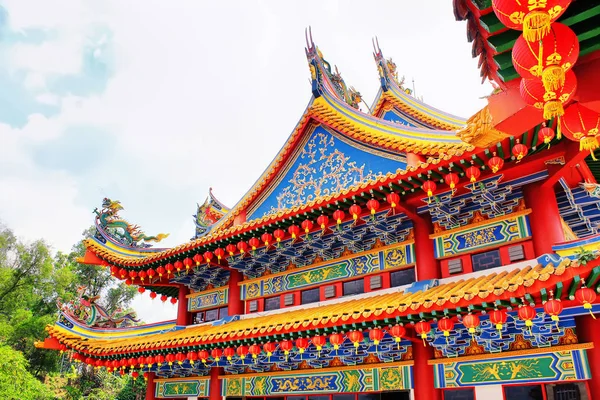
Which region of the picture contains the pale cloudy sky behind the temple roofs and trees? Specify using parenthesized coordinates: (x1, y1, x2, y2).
(0, 0, 491, 321)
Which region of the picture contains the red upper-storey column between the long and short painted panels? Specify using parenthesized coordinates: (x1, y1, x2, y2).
(413, 215, 440, 281)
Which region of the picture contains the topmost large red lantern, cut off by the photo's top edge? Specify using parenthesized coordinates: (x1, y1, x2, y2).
(492, 0, 571, 42)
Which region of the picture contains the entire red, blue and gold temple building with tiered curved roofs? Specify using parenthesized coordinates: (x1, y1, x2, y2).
(40, 0, 600, 400)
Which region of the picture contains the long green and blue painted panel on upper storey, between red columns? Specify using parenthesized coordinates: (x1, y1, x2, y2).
(241, 242, 414, 300)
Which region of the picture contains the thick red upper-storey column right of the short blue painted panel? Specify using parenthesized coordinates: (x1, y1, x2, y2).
(523, 182, 565, 256)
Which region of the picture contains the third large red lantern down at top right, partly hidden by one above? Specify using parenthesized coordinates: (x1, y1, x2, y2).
(521, 70, 577, 119)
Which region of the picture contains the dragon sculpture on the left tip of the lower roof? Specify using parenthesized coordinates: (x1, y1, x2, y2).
(57, 286, 139, 328)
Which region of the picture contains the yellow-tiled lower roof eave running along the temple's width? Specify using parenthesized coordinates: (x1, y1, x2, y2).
(42, 259, 598, 356)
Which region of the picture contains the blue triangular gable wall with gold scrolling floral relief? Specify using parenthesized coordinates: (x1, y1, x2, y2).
(248, 126, 406, 220)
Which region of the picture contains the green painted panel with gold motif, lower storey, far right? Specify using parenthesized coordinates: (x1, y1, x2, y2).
(434, 348, 590, 388)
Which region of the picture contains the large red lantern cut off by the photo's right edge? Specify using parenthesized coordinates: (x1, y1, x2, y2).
(560, 103, 600, 160)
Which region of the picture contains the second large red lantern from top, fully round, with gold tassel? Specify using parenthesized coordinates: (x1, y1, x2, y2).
(512, 23, 579, 92)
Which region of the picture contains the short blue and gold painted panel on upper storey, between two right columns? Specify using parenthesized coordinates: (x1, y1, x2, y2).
(431, 210, 531, 258)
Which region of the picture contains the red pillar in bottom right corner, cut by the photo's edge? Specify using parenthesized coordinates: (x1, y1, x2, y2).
(575, 315, 600, 400)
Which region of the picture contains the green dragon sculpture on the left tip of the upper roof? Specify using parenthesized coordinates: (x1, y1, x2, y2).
(94, 198, 169, 248)
